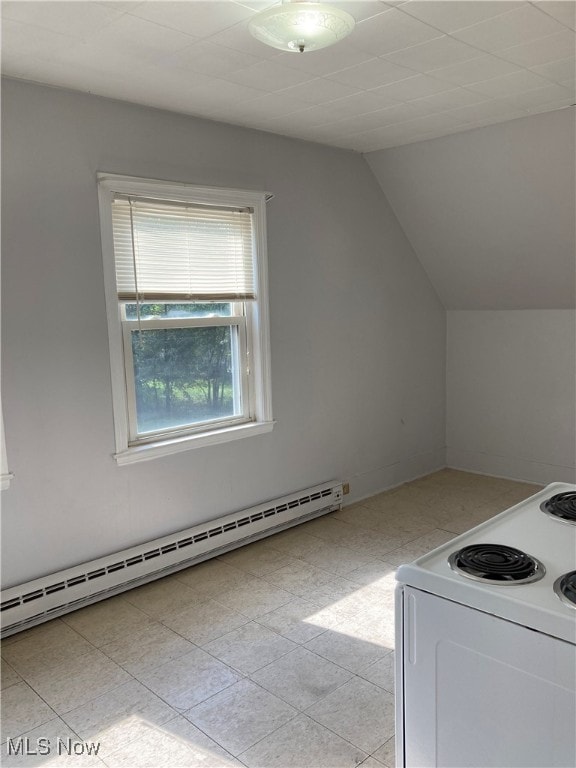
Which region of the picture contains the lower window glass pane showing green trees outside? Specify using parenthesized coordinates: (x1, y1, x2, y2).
(131, 325, 242, 434)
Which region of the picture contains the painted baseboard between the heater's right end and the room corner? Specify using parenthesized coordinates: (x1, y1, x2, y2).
(344, 448, 446, 506)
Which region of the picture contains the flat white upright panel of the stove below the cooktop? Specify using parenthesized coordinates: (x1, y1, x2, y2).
(397, 586, 576, 768)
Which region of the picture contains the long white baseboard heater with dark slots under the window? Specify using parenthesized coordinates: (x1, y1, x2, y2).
(1, 481, 342, 637)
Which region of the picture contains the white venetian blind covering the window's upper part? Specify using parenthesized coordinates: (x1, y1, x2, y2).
(112, 194, 255, 301)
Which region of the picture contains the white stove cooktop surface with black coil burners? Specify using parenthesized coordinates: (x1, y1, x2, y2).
(396, 483, 576, 644)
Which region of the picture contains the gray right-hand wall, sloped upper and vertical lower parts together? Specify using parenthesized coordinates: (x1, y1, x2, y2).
(367, 109, 576, 483)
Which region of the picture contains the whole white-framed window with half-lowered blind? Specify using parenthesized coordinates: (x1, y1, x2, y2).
(99, 174, 272, 464)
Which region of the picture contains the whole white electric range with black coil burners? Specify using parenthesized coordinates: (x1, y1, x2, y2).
(396, 483, 576, 768)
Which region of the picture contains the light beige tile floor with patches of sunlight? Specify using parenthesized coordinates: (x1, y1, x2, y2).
(1, 470, 538, 768)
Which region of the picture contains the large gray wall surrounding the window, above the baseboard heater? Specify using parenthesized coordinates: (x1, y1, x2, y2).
(2, 81, 445, 587)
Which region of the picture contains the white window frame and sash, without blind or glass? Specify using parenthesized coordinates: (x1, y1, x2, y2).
(97, 173, 274, 465)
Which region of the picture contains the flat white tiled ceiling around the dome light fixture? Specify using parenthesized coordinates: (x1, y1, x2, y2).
(2, 0, 576, 152)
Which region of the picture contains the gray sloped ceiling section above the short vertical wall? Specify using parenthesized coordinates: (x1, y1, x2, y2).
(365, 107, 576, 309)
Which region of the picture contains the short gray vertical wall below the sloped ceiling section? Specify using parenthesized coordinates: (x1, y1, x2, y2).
(447, 310, 576, 483)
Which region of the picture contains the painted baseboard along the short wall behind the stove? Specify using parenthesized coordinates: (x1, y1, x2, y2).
(446, 448, 576, 485)
